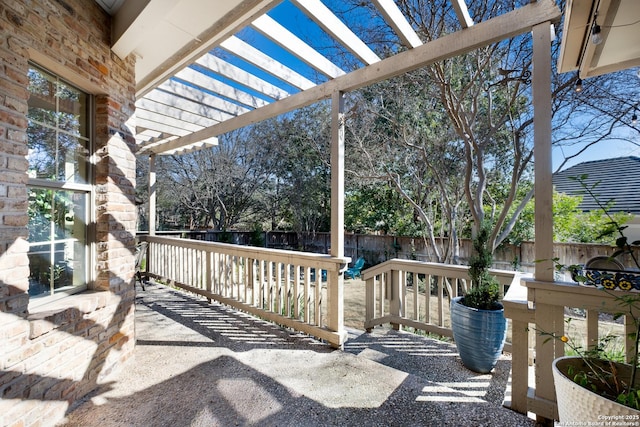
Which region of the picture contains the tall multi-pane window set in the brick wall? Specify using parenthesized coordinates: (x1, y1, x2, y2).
(27, 65, 93, 298)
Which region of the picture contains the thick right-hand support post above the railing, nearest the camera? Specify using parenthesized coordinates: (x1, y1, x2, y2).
(532, 22, 554, 282)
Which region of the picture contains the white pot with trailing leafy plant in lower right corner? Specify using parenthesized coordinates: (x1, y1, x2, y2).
(541, 175, 640, 425)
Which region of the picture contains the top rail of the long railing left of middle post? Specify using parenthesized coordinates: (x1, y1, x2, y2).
(140, 236, 351, 271)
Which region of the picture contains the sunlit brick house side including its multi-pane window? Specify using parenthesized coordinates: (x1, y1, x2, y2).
(0, 0, 137, 426)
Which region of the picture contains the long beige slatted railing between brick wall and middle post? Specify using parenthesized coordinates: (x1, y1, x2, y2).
(141, 236, 350, 347)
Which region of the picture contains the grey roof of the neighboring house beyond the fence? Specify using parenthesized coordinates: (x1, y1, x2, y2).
(553, 157, 640, 240)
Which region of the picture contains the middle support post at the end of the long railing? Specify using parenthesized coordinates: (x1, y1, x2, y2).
(327, 91, 346, 342)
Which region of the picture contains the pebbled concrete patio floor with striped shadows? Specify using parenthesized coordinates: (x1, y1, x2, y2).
(60, 284, 535, 427)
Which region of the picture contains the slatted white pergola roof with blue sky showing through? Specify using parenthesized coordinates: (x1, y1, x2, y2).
(96, 0, 559, 154)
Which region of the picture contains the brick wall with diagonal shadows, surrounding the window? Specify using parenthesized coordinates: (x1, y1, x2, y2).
(0, 0, 136, 426)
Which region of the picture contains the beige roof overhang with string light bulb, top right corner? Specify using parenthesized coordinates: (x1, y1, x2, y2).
(558, 0, 640, 79)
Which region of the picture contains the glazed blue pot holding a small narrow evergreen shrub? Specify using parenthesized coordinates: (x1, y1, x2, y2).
(451, 226, 507, 373)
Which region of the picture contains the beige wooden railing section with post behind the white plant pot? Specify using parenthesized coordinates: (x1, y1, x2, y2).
(505, 279, 640, 420)
